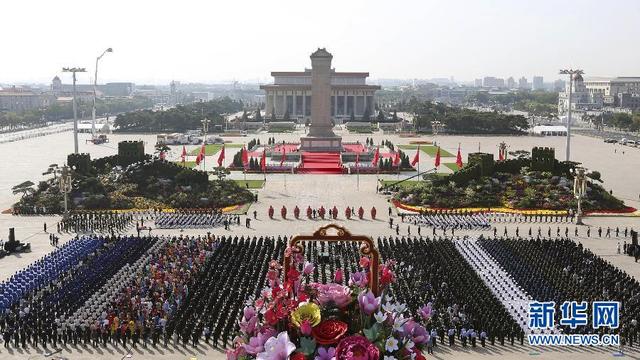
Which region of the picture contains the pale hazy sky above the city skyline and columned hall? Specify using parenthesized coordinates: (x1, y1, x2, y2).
(5, 0, 640, 84)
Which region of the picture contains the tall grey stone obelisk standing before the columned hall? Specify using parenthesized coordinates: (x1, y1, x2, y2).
(300, 48, 342, 151)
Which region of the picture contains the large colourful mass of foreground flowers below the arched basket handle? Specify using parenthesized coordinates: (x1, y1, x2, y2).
(227, 249, 434, 360)
